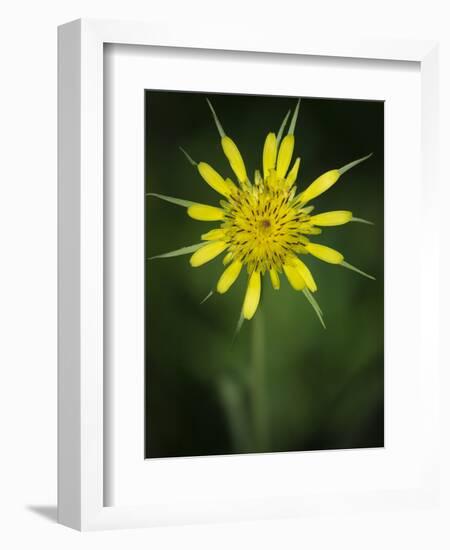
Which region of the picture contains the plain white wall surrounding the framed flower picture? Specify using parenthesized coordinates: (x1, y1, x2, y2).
(0, 0, 450, 550)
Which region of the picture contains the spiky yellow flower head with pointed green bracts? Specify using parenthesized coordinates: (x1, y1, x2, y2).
(150, 100, 373, 324)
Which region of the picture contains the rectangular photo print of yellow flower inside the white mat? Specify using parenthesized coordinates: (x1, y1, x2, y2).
(145, 90, 384, 458)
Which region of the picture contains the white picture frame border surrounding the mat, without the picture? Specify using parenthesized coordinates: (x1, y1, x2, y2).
(58, 20, 439, 530)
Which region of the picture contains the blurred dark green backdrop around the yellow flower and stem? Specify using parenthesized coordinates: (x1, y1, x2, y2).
(145, 91, 384, 458)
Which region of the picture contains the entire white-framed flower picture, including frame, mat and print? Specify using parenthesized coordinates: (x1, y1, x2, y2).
(58, 20, 439, 530)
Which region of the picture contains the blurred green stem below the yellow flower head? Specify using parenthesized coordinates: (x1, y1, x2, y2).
(250, 307, 268, 451)
